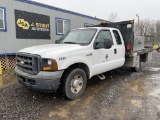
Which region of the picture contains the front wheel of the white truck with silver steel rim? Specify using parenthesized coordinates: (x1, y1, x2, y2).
(62, 68, 87, 100)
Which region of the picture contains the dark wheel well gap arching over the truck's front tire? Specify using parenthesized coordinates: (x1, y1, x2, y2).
(62, 63, 90, 79)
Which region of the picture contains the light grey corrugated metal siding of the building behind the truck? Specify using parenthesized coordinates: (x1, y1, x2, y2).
(0, 0, 102, 54)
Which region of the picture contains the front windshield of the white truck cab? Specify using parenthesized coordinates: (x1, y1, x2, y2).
(58, 28, 97, 45)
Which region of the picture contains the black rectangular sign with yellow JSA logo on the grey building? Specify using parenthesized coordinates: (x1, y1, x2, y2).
(15, 10, 51, 39)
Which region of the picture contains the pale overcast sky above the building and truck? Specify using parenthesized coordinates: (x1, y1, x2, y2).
(32, 0, 160, 21)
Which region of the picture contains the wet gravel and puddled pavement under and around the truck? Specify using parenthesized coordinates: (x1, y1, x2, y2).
(0, 52, 160, 120)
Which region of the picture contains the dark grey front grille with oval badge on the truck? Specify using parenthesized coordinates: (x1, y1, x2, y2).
(16, 53, 40, 75)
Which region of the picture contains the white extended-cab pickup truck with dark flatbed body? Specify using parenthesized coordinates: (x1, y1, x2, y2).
(15, 20, 152, 99)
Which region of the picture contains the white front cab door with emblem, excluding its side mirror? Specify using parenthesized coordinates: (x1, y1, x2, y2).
(92, 29, 117, 75)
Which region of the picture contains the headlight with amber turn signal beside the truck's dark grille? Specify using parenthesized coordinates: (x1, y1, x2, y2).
(41, 59, 58, 71)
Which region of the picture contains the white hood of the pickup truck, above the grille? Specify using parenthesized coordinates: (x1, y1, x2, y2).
(19, 44, 83, 58)
